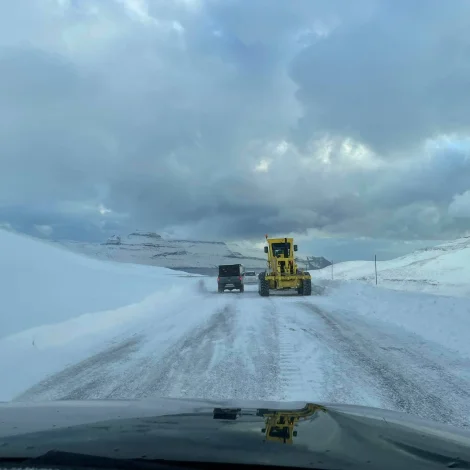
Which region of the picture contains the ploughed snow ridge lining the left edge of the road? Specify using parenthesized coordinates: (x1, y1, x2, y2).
(0, 279, 220, 401)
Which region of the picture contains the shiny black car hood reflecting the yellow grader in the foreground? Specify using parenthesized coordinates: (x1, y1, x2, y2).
(0, 399, 470, 469)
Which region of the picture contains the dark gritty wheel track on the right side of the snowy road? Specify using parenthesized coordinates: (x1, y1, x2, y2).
(300, 303, 470, 427)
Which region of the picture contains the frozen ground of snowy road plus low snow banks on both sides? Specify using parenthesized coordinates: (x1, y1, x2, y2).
(0, 229, 470, 426)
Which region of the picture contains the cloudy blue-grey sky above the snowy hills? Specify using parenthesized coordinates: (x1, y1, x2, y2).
(0, 0, 470, 259)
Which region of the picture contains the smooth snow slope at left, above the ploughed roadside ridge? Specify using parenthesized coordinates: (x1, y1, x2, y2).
(0, 230, 191, 338)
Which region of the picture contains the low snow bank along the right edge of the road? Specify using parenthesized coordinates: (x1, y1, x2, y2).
(315, 281, 470, 357)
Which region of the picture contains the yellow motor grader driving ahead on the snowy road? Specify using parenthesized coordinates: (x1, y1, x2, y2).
(258, 235, 312, 297)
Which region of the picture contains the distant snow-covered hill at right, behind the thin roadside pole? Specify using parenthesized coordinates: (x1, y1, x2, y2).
(311, 237, 470, 296)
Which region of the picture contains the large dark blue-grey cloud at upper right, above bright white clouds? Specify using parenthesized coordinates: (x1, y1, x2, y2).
(291, 0, 470, 154)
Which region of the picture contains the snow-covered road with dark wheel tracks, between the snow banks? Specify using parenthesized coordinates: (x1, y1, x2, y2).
(17, 287, 470, 426)
